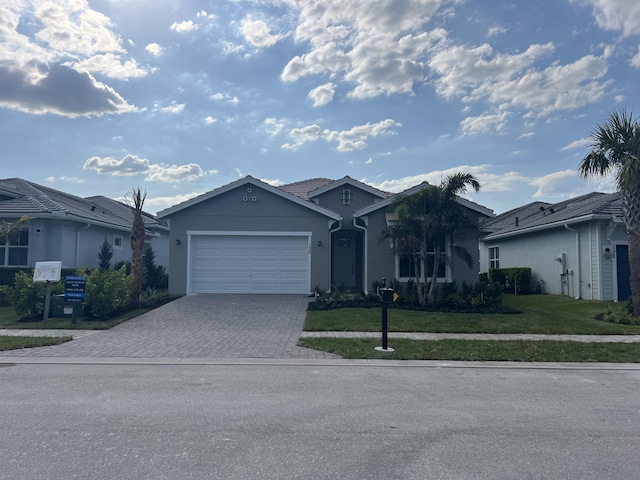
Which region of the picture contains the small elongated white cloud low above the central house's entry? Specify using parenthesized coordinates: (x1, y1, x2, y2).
(282, 119, 402, 152)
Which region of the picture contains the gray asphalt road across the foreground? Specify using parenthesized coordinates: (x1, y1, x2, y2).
(0, 362, 640, 480)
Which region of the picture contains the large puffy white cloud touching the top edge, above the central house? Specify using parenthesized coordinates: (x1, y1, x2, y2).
(281, 0, 449, 98)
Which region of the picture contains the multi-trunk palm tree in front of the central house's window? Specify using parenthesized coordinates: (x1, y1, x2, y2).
(381, 173, 480, 305)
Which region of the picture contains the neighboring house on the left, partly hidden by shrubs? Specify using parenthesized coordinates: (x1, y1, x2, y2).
(0, 178, 169, 268)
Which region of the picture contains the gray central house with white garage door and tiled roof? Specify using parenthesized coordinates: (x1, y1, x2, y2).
(158, 176, 492, 294)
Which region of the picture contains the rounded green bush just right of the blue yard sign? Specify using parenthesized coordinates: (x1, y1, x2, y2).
(85, 265, 133, 318)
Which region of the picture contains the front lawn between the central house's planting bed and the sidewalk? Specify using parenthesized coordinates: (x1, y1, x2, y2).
(304, 295, 640, 335)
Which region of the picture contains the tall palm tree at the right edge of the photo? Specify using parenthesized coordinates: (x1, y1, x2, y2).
(579, 109, 640, 316)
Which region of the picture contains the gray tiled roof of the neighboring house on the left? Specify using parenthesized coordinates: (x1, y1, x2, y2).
(0, 178, 166, 231)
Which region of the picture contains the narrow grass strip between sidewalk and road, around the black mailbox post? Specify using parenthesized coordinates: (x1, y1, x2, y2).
(298, 338, 640, 363)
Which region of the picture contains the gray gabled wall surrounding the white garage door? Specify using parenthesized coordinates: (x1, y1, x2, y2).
(169, 185, 333, 294)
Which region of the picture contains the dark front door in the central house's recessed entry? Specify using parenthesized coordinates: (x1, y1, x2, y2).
(331, 230, 362, 289)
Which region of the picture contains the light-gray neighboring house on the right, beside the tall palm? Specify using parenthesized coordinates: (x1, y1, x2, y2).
(480, 192, 631, 301)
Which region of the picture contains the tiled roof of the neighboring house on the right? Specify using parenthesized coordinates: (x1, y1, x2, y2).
(483, 192, 623, 241)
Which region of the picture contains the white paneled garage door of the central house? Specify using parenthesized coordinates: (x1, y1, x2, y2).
(188, 235, 311, 294)
